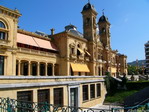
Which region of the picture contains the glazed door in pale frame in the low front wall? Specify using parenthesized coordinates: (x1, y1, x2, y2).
(70, 88, 78, 107)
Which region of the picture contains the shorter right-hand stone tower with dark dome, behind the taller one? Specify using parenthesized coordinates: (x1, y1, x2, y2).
(98, 13, 111, 49)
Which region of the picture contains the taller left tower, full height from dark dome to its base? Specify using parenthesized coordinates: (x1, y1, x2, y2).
(82, 2, 97, 75)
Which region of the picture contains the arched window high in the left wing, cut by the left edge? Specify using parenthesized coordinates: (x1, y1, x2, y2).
(0, 21, 7, 40)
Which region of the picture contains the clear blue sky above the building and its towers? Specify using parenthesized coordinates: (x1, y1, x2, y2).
(0, 0, 149, 62)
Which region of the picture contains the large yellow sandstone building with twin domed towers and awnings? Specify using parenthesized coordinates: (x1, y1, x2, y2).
(0, 3, 127, 107)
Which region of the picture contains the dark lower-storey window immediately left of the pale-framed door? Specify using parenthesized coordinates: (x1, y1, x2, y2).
(54, 88, 63, 106)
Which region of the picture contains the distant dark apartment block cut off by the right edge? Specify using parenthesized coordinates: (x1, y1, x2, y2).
(144, 41, 149, 73)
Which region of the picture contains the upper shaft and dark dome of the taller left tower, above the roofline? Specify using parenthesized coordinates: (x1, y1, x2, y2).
(81, 2, 97, 41)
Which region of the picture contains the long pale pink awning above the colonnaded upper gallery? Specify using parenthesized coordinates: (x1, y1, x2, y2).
(17, 33, 58, 51)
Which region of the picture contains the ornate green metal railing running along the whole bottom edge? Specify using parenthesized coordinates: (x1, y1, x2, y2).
(0, 97, 149, 112)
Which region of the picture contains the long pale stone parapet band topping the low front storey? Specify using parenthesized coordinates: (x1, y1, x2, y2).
(0, 76, 104, 89)
